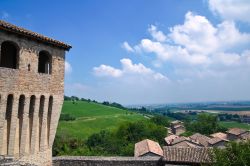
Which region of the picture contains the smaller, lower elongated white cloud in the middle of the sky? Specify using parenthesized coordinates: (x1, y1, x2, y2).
(93, 58, 167, 80)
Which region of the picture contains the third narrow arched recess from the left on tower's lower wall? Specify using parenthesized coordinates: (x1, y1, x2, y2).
(28, 95, 36, 150)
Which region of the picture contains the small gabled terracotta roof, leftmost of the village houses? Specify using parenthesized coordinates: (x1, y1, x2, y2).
(134, 139, 163, 157)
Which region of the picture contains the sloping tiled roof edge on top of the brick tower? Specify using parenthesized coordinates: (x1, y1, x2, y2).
(0, 20, 71, 50)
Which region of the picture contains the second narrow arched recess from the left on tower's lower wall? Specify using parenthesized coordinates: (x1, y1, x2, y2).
(17, 95, 25, 152)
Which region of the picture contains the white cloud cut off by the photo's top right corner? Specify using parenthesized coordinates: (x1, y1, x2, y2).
(208, 0, 250, 23)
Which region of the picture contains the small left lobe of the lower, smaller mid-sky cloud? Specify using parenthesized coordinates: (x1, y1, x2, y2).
(93, 65, 122, 77)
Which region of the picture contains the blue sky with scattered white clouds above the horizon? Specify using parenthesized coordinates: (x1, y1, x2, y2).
(0, 0, 250, 104)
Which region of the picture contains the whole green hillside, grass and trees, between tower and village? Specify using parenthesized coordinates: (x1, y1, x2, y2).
(53, 100, 169, 156)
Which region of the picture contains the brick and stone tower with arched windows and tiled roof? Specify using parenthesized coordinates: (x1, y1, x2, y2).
(0, 20, 71, 165)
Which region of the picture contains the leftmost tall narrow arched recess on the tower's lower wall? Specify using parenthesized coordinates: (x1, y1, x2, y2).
(5, 95, 13, 154)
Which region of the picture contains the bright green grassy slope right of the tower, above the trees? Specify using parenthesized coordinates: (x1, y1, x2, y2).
(57, 101, 145, 139)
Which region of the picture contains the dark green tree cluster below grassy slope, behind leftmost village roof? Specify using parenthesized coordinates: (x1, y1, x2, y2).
(86, 120, 167, 156)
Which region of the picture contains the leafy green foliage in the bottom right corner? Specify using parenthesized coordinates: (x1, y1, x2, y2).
(213, 141, 250, 166)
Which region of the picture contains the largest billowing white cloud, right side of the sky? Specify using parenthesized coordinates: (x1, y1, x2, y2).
(136, 12, 250, 67)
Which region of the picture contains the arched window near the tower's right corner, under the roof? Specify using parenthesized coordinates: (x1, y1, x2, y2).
(38, 51, 52, 74)
